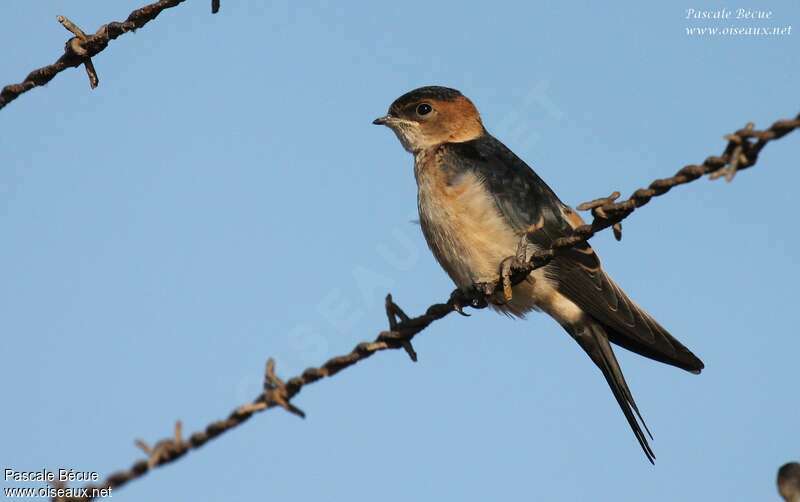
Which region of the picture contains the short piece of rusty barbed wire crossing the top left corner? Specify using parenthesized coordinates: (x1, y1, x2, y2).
(0, 0, 219, 109)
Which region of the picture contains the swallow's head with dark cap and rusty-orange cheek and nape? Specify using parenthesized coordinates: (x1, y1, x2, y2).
(372, 86, 486, 153)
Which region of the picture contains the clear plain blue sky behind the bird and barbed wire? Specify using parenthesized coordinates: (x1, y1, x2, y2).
(0, 0, 800, 502)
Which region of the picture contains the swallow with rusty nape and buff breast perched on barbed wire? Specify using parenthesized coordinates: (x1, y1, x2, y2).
(373, 86, 704, 464)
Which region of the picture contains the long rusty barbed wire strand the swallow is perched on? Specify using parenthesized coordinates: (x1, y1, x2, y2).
(52, 114, 800, 502)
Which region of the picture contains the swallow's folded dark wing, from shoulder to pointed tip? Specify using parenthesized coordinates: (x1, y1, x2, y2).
(448, 135, 703, 373)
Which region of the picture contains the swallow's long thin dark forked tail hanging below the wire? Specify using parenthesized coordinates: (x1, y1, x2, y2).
(568, 320, 656, 464)
